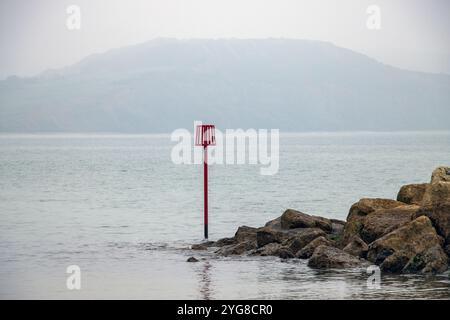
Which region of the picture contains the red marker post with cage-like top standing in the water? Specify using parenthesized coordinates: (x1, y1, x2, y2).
(195, 124, 216, 239)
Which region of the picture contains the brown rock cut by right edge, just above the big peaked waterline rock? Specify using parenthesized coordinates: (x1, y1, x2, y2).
(416, 204, 450, 244)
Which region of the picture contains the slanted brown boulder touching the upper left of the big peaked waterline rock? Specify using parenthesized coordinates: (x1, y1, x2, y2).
(359, 205, 420, 243)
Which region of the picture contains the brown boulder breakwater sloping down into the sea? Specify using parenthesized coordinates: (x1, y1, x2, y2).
(192, 167, 450, 273)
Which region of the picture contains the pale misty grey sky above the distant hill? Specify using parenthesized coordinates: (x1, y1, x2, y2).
(0, 0, 450, 79)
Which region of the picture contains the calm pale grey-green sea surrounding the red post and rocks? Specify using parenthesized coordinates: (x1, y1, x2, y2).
(0, 132, 450, 299)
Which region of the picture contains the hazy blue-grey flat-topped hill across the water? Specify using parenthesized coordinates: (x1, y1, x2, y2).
(0, 39, 450, 132)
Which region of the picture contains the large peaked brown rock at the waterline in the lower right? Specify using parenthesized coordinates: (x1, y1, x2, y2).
(367, 216, 447, 272)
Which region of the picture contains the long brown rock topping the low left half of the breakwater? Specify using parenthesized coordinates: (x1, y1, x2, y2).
(280, 209, 332, 232)
